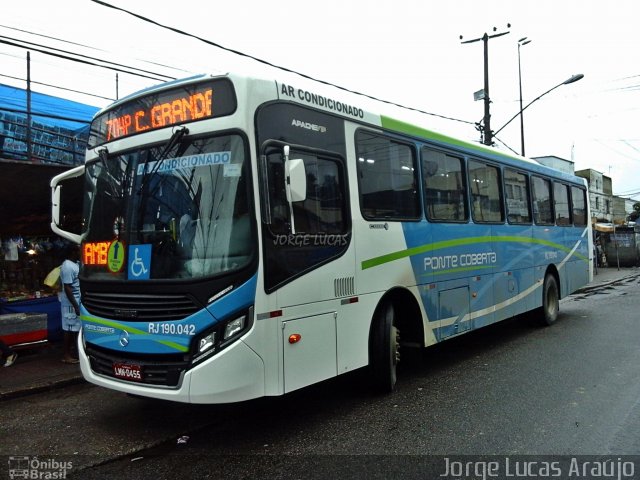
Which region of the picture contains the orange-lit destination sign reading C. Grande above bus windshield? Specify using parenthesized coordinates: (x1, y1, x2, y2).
(89, 79, 236, 147)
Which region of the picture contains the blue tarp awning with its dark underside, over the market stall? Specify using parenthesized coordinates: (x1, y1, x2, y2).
(0, 84, 98, 235)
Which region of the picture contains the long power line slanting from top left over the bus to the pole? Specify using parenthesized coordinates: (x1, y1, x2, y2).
(91, 0, 476, 125)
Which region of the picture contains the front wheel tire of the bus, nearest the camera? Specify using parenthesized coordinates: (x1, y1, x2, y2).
(369, 302, 400, 393)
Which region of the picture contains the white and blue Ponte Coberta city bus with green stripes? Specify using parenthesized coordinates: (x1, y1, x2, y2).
(51, 70, 592, 403)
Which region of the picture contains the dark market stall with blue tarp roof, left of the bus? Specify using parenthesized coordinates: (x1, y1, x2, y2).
(0, 84, 98, 345)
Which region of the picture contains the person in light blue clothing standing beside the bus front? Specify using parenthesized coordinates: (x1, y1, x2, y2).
(60, 245, 80, 363)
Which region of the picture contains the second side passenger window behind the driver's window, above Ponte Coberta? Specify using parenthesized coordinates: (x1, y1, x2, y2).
(422, 147, 469, 222)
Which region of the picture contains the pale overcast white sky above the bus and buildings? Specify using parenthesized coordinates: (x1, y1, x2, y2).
(0, 0, 640, 199)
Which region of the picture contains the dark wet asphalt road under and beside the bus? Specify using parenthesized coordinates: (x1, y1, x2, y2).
(0, 278, 640, 480)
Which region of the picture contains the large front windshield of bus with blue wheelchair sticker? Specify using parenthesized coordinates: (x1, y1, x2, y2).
(82, 135, 257, 280)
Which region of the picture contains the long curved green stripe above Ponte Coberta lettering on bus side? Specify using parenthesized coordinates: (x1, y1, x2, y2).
(361, 236, 589, 270)
